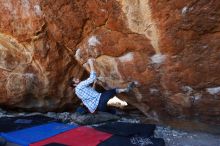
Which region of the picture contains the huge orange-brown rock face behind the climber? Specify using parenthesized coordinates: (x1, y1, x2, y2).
(0, 0, 220, 124)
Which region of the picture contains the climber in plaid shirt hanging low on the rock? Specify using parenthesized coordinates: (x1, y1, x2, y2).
(68, 58, 135, 113)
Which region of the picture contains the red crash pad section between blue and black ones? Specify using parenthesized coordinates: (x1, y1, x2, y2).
(30, 126, 112, 146)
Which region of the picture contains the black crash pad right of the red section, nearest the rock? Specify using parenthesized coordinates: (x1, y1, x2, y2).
(94, 122, 156, 137)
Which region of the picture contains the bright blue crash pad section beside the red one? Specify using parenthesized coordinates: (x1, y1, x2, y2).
(1, 122, 77, 146)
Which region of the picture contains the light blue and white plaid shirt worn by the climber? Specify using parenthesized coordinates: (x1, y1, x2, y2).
(75, 72, 101, 113)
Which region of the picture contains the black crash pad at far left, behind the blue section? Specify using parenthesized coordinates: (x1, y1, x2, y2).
(0, 115, 57, 132)
